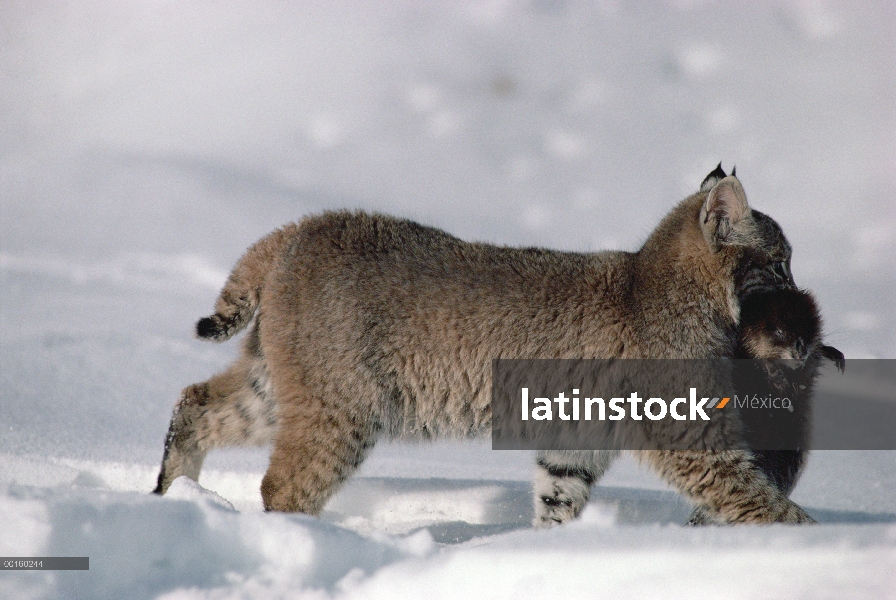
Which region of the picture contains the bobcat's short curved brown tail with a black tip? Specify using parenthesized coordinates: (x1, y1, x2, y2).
(196, 223, 298, 342)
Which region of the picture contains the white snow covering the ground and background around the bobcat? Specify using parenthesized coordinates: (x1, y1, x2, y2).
(0, 0, 896, 599)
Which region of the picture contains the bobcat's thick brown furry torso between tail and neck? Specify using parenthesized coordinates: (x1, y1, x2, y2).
(260, 212, 637, 437)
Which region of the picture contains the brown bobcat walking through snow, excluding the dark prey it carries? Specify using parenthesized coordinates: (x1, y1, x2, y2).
(155, 165, 812, 525)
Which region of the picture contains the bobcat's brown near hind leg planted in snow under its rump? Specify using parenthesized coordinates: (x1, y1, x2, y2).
(261, 398, 380, 515)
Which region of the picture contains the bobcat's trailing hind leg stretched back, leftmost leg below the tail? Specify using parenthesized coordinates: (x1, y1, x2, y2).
(153, 359, 277, 494)
